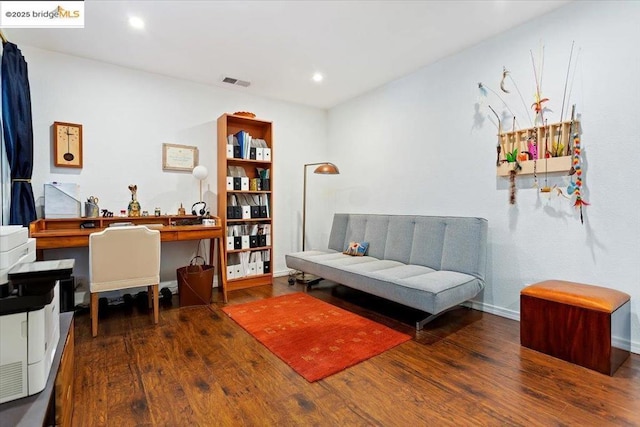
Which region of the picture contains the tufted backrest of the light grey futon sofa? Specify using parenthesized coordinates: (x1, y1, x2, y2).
(329, 213, 488, 281)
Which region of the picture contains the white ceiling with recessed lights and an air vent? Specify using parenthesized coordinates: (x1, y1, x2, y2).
(4, 0, 568, 108)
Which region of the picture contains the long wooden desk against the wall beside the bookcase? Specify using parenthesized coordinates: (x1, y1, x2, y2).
(29, 215, 226, 295)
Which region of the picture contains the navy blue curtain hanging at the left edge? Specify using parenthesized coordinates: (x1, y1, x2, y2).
(2, 42, 36, 227)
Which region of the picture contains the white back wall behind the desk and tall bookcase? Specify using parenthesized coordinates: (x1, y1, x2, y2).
(21, 42, 326, 298)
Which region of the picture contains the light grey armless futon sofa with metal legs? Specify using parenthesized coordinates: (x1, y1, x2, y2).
(285, 214, 487, 330)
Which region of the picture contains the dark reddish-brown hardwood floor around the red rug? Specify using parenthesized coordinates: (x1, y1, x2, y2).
(73, 278, 640, 427)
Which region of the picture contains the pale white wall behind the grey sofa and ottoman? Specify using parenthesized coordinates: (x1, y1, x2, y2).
(324, 2, 640, 352)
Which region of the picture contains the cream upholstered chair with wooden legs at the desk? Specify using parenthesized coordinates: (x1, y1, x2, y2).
(89, 226, 160, 337)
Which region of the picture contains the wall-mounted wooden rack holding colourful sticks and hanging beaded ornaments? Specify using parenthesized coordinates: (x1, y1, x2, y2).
(478, 43, 588, 222)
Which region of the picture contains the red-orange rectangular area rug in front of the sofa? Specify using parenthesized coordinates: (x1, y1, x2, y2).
(222, 293, 411, 382)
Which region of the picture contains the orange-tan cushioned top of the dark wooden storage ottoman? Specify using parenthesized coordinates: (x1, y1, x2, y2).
(520, 280, 631, 313)
